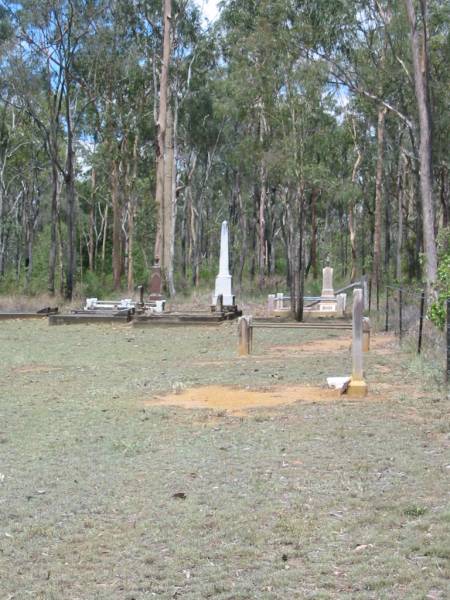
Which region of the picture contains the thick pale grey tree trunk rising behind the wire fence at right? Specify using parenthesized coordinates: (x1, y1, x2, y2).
(405, 0, 437, 292)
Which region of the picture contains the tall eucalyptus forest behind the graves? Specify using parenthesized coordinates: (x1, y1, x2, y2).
(0, 0, 450, 321)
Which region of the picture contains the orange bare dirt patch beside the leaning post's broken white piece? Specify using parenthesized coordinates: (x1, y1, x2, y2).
(145, 385, 354, 415)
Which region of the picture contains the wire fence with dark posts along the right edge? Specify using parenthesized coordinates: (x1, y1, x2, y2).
(370, 285, 450, 383)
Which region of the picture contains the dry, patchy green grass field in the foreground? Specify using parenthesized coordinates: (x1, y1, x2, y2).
(0, 321, 450, 600)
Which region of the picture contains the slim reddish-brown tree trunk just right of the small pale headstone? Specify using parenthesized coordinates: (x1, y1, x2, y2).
(372, 106, 386, 310)
